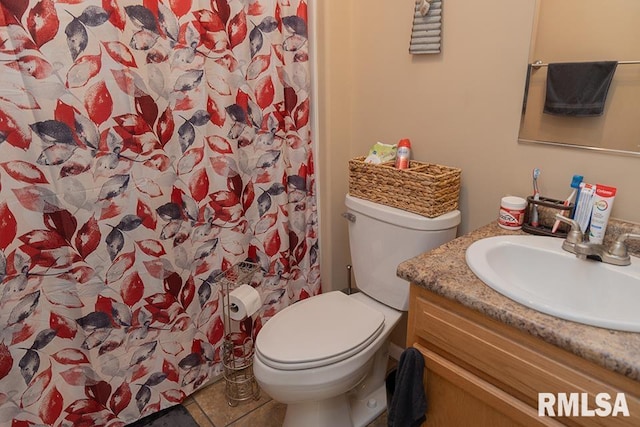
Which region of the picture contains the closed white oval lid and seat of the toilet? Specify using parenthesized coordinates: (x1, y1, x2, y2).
(256, 291, 384, 370)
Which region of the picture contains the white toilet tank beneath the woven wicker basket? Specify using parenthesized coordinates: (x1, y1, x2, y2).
(345, 194, 460, 311)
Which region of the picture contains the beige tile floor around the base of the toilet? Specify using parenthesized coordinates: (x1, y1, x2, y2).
(182, 379, 387, 427)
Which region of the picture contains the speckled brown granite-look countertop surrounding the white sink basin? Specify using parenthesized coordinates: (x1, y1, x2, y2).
(397, 223, 640, 381)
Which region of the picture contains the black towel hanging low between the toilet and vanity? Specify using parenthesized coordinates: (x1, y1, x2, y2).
(387, 347, 427, 427)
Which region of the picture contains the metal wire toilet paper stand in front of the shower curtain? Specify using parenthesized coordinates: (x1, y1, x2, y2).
(214, 261, 260, 406)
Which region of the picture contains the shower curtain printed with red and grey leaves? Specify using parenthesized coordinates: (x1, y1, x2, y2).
(0, 0, 320, 427)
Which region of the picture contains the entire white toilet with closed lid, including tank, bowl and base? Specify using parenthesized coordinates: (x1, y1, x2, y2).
(253, 195, 460, 427)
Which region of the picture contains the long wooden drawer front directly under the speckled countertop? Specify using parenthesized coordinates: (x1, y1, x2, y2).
(409, 295, 640, 426)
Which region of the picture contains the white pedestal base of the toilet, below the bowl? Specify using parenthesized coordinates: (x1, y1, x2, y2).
(283, 384, 387, 427)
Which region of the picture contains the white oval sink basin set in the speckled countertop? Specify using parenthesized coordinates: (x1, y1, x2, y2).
(466, 236, 640, 332)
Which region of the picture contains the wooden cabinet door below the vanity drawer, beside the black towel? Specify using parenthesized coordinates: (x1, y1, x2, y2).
(413, 343, 562, 427)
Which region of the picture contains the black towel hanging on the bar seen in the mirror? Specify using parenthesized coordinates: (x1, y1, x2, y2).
(544, 61, 618, 117)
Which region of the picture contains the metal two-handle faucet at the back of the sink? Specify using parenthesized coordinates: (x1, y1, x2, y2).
(556, 214, 640, 266)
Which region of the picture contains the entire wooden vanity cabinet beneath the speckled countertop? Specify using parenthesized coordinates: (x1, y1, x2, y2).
(407, 285, 640, 427)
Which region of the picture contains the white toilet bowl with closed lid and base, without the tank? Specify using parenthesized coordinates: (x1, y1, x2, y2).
(253, 291, 402, 427)
